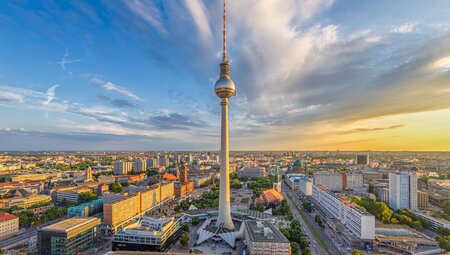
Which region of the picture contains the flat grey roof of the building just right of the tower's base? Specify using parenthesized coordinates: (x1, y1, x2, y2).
(245, 220, 289, 243)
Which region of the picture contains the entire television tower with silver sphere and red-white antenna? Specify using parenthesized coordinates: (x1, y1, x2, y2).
(214, 0, 236, 230)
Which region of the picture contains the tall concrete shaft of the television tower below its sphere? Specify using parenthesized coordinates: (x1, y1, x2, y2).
(216, 98, 234, 229)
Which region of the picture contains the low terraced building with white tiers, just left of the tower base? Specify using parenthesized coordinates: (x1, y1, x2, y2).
(112, 216, 182, 252)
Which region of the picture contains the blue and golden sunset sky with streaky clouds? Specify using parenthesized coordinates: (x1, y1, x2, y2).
(0, 0, 450, 151)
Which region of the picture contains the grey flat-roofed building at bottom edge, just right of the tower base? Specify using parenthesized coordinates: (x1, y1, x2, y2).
(244, 220, 291, 255)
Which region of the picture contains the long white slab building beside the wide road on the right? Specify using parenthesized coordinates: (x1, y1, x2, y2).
(312, 185, 375, 240)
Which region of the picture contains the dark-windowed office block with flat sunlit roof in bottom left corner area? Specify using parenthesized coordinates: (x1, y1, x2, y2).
(37, 218, 101, 255)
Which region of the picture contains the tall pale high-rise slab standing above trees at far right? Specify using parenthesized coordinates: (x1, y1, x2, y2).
(389, 172, 417, 210)
